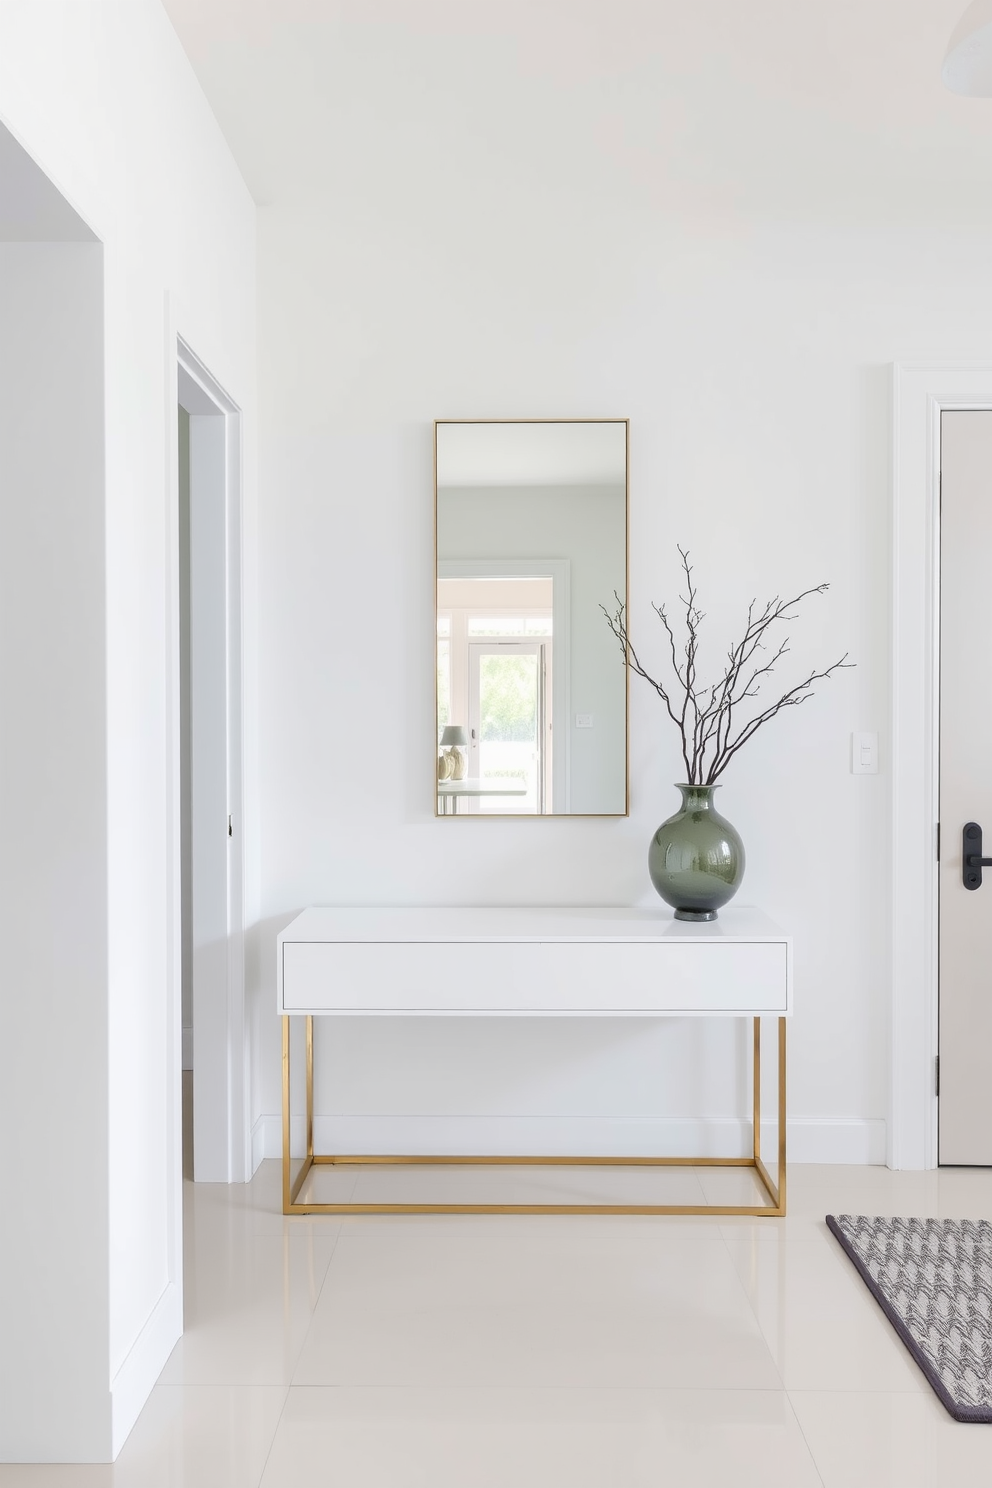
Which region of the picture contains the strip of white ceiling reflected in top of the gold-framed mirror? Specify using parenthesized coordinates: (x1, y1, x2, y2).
(437, 423, 626, 487)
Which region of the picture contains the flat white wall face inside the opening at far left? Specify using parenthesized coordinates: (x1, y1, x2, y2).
(0, 238, 110, 1457)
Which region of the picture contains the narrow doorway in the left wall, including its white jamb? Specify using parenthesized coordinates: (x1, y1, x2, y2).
(171, 339, 250, 1183)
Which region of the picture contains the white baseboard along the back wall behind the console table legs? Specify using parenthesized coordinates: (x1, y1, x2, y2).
(251, 1116, 885, 1171)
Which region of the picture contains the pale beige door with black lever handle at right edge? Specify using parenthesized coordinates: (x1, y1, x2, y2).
(937, 411, 992, 1167)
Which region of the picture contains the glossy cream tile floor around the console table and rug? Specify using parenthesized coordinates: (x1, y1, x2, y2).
(0, 1162, 992, 1488)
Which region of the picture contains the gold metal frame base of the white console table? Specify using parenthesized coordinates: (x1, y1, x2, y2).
(283, 1015, 785, 1219)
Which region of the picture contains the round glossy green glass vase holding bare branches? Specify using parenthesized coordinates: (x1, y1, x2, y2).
(647, 786, 744, 920)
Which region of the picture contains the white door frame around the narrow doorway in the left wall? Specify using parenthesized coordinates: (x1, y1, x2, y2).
(167, 325, 251, 1183)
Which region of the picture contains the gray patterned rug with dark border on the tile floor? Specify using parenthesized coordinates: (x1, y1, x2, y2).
(827, 1214, 992, 1421)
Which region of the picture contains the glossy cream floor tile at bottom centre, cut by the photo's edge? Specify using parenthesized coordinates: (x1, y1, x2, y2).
(255, 1388, 821, 1488)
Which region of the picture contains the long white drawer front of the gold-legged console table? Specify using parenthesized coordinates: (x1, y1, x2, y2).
(283, 940, 788, 1016)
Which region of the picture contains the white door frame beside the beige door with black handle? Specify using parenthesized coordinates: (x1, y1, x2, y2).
(888, 363, 992, 1168)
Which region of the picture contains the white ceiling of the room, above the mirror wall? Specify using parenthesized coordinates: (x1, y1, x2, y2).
(164, 0, 992, 220)
